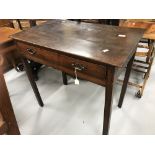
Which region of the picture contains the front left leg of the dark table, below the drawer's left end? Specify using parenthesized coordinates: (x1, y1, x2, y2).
(22, 58, 44, 107)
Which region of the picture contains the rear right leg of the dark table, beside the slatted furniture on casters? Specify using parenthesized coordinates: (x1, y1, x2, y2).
(118, 55, 135, 108)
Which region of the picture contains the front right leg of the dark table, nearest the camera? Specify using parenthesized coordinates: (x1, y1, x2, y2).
(102, 66, 115, 135)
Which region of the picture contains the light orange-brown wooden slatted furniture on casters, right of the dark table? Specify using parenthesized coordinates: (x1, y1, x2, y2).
(119, 21, 155, 98)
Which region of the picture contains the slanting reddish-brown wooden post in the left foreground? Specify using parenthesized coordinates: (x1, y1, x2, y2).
(0, 57, 20, 135)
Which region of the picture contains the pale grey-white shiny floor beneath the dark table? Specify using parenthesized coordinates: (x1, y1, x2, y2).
(5, 59, 155, 135)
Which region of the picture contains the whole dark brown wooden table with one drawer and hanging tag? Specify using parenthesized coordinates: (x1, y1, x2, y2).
(12, 20, 144, 134)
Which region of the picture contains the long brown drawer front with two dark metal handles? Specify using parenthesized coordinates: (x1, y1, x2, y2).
(17, 42, 106, 85)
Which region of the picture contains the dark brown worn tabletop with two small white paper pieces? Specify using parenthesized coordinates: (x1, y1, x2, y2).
(12, 20, 144, 67)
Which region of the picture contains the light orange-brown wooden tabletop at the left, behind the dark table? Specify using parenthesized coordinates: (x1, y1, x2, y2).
(0, 27, 20, 45)
